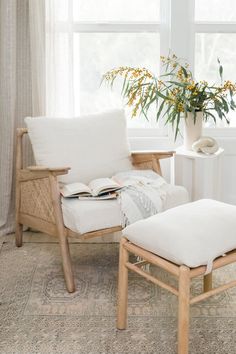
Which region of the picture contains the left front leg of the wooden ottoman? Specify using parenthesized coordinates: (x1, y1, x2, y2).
(117, 238, 129, 329)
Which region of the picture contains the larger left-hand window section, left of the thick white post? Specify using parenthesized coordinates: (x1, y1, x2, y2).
(47, 0, 160, 127)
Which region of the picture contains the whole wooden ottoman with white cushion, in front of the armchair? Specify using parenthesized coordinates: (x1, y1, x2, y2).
(117, 199, 236, 354)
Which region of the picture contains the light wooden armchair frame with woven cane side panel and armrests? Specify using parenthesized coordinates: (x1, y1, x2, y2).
(16, 128, 174, 292)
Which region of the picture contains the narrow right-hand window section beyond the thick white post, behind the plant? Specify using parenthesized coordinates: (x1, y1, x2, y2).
(195, 0, 236, 127)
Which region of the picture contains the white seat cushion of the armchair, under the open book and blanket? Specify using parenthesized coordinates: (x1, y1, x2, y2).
(62, 184, 188, 234)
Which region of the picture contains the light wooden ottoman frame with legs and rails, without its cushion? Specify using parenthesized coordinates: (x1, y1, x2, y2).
(117, 237, 236, 354)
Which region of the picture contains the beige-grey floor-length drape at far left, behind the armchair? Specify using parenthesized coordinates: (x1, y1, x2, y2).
(0, 0, 45, 236)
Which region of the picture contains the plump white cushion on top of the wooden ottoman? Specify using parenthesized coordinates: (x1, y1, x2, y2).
(123, 199, 236, 271)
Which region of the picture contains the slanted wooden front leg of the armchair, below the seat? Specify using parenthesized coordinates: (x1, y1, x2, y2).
(59, 236, 75, 293)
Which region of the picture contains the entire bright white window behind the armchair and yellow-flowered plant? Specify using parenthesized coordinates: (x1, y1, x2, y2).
(46, 0, 236, 136)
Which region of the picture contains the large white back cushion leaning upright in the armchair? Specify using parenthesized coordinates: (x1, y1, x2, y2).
(25, 110, 132, 183)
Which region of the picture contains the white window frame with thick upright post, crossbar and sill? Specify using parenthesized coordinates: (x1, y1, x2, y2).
(54, 0, 236, 140)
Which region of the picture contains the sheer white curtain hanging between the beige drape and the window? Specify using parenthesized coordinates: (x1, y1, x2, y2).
(45, 0, 74, 116)
